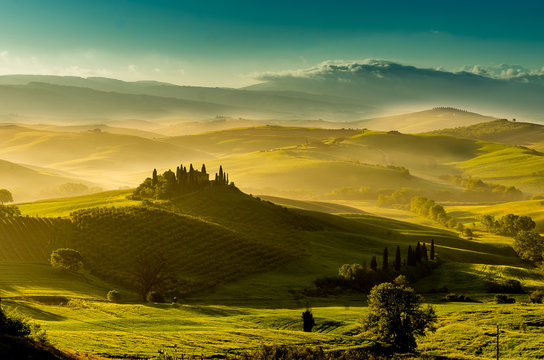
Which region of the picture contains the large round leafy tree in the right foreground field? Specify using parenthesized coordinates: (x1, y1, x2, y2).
(361, 283, 437, 351)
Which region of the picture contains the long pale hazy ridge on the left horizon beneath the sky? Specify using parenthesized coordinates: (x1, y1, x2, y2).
(0, 75, 371, 121)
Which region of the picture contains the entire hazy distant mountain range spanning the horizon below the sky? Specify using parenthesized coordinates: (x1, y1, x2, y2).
(0, 61, 544, 124)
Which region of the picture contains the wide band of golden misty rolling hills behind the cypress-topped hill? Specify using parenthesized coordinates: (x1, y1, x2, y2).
(4, 117, 544, 199)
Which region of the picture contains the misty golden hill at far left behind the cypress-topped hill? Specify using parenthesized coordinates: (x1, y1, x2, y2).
(0, 125, 213, 187)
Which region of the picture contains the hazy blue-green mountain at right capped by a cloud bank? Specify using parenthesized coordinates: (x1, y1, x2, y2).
(246, 60, 544, 120)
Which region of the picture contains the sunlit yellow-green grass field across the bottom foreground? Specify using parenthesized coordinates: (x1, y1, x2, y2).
(0, 263, 544, 359)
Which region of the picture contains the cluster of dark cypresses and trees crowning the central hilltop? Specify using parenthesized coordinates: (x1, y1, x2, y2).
(133, 164, 233, 199)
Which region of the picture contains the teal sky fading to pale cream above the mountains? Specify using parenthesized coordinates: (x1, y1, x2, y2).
(0, 0, 544, 87)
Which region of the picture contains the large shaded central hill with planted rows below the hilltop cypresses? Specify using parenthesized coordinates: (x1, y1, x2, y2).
(9, 186, 519, 298)
